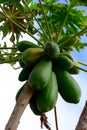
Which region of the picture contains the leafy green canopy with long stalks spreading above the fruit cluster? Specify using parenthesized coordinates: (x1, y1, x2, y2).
(0, 0, 87, 68)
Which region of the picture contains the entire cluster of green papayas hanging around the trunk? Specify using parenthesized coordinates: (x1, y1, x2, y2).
(16, 41, 81, 115)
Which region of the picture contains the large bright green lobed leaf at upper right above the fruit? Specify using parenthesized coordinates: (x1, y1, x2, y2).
(38, 2, 87, 40)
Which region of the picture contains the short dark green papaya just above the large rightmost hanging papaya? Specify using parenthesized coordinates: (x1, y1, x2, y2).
(55, 55, 73, 70)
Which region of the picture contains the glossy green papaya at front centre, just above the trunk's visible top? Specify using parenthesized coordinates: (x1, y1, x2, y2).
(28, 59, 52, 90)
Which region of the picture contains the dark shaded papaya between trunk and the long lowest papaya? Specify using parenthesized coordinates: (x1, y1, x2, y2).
(29, 92, 42, 116)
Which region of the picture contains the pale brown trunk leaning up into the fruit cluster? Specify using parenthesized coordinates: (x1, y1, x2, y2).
(5, 82, 34, 130)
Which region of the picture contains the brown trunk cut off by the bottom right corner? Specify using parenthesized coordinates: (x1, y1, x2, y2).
(75, 101, 87, 130)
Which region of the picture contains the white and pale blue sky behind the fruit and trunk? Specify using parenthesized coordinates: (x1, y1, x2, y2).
(0, 2, 87, 130)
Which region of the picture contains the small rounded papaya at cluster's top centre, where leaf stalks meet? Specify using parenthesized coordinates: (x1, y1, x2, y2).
(45, 41, 60, 60)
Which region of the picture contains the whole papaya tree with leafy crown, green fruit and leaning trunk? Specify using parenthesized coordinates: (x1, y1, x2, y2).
(0, 0, 87, 130)
